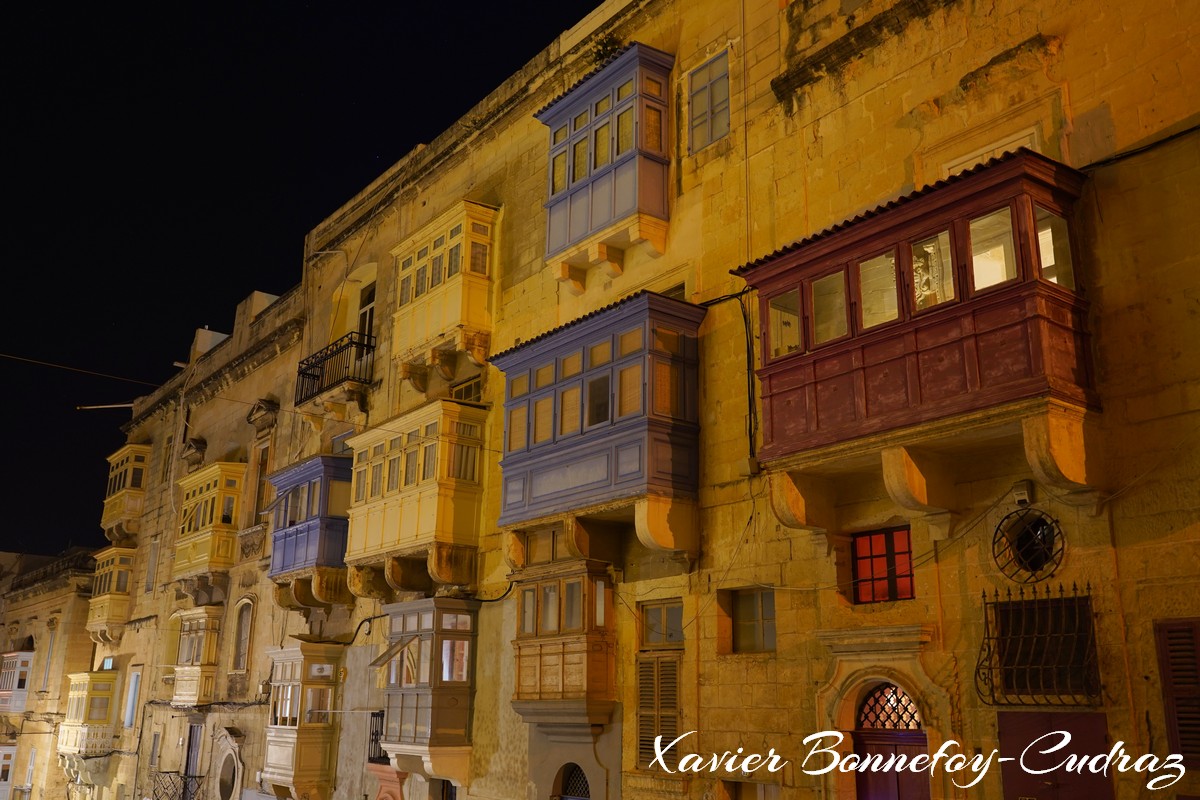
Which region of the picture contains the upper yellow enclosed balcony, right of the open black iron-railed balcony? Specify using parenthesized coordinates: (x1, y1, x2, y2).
(391, 200, 496, 374)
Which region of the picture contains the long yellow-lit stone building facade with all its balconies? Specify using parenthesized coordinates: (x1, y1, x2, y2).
(0, 0, 1200, 800)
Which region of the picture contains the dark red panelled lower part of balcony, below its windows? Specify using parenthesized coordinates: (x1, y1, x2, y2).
(758, 282, 1096, 459)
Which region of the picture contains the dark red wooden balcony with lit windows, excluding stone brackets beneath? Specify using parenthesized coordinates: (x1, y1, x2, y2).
(736, 150, 1097, 461)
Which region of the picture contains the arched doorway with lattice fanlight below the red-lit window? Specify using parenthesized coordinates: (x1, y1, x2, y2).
(853, 684, 929, 800)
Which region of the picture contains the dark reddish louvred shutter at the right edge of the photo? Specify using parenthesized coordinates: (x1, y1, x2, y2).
(1154, 618, 1200, 768)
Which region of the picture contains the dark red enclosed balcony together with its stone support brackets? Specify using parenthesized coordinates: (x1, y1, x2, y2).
(734, 149, 1098, 534)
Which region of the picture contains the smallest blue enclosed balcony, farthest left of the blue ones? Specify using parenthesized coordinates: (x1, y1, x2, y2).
(268, 456, 350, 606)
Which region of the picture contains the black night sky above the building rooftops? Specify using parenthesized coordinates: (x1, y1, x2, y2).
(0, 0, 599, 554)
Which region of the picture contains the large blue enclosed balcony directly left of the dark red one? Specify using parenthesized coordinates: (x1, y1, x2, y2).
(492, 291, 704, 549)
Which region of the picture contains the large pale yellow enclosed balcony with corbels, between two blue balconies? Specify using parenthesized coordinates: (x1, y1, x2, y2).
(346, 399, 486, 601)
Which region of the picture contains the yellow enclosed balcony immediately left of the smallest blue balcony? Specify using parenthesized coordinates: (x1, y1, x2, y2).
(170, 462, 246, 604)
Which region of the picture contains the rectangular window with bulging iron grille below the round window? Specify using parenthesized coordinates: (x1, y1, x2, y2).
(976, 585, 1100, 705)
